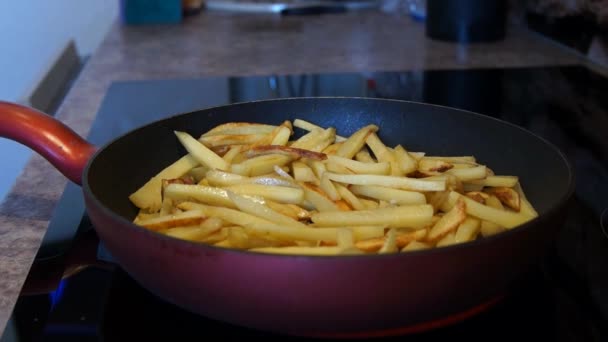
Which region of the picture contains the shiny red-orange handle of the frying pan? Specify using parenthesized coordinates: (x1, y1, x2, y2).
(0, 101, 97, 185)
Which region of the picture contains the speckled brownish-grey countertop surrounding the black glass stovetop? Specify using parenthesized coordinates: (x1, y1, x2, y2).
(0, 12, 586, 335)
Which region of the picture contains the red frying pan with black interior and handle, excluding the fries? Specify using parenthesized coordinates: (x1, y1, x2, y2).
(0, 98, 574, 337)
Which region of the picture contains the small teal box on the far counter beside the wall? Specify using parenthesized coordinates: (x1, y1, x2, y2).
(120, 0, 182, 25)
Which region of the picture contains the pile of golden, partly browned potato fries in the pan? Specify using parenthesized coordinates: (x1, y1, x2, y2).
(129, 119, 538, 255)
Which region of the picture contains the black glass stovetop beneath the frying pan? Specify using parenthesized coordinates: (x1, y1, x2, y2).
(5, 66, 608, 341)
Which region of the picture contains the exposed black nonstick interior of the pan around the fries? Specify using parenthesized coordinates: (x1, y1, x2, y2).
(85, 98, 572, 220)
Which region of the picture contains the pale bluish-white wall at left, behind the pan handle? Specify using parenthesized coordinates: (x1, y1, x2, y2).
(0, 0, 119, 200)
